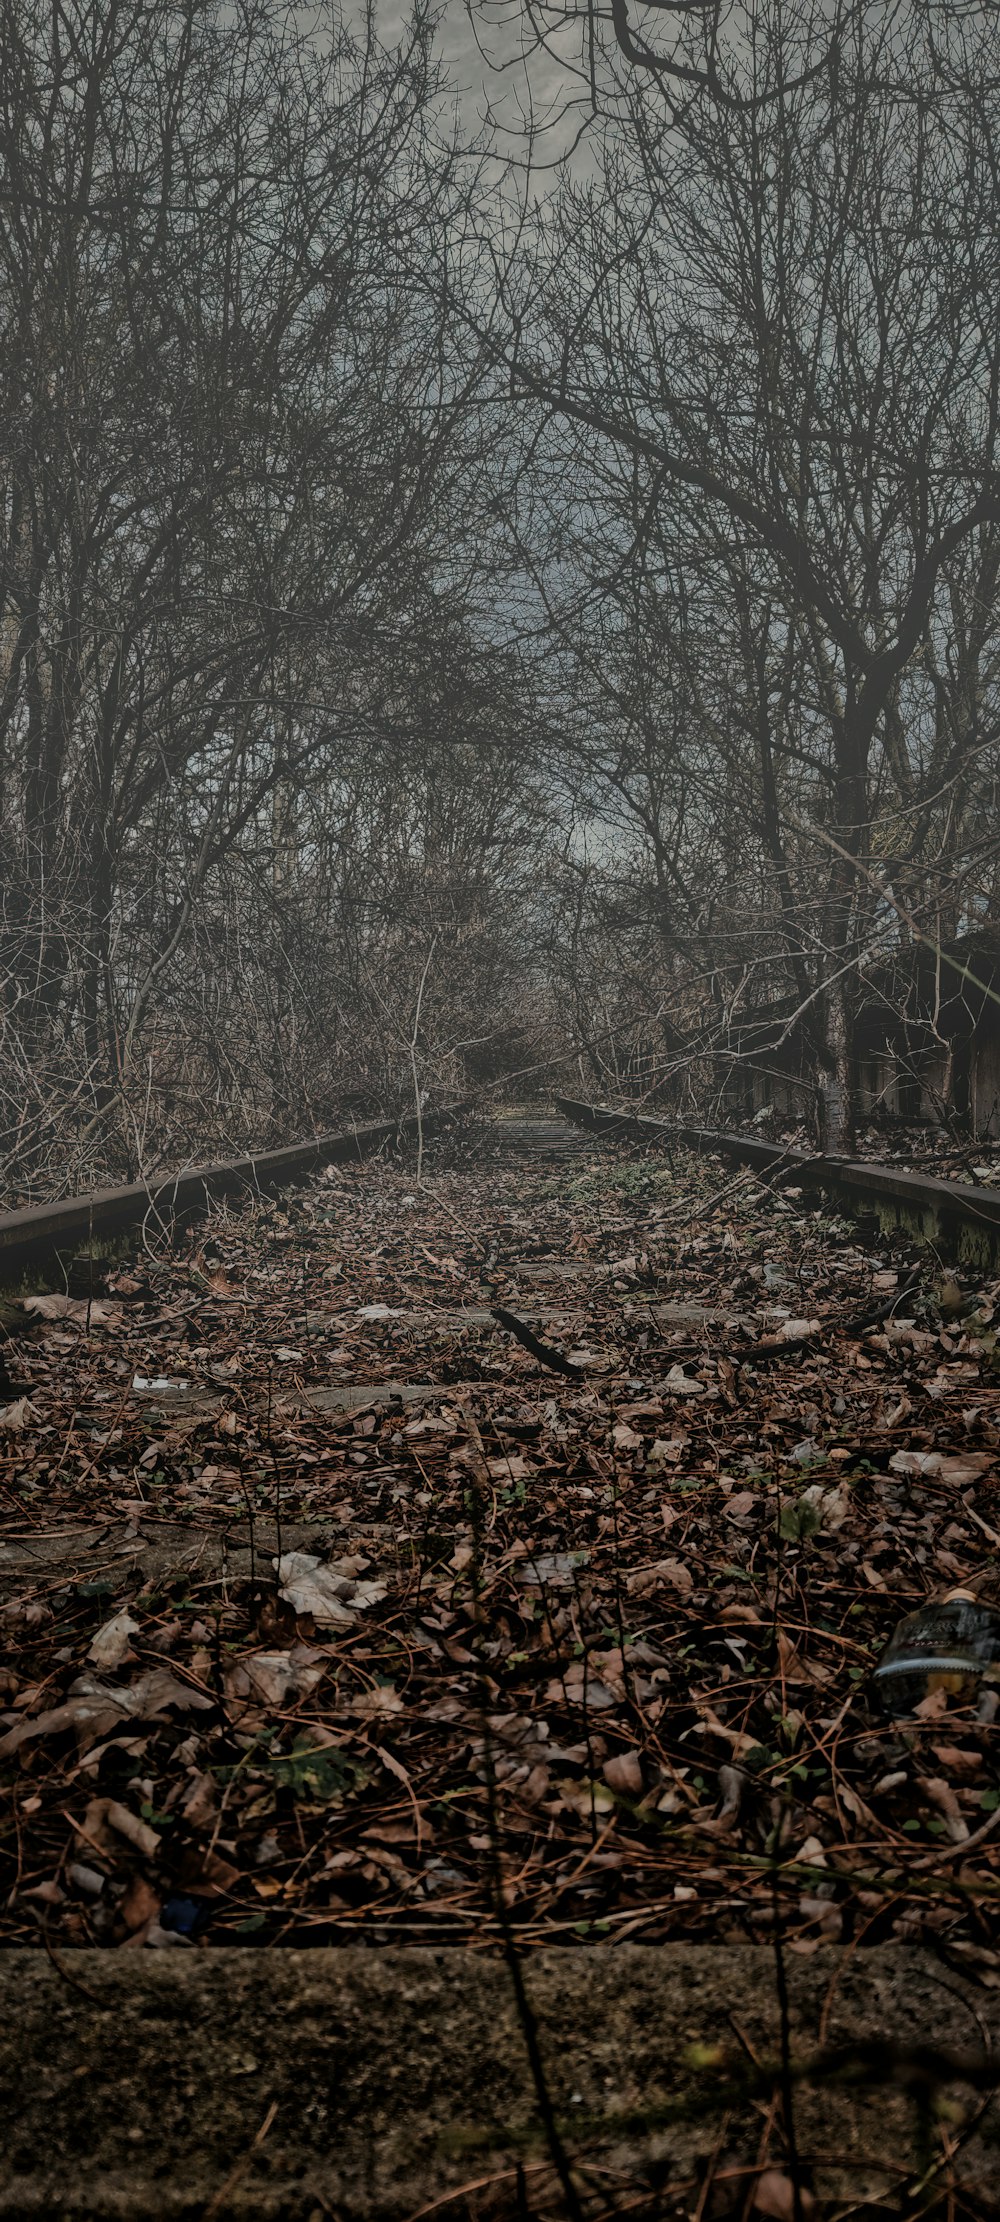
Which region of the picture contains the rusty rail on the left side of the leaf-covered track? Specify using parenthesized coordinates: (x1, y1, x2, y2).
(0, 1104, 464, 1287)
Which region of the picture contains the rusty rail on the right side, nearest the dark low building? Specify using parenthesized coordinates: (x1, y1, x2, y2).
(556, 1095, 1000, 1273)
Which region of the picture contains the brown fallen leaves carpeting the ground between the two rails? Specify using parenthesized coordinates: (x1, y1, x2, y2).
(0, 1111, 1000, 1982)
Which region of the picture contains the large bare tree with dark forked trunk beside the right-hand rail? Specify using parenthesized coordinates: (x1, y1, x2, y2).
(471, 0, 1000, 1147)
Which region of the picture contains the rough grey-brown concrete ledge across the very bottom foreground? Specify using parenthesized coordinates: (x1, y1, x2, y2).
(0, 1944, 1000, 2222)
